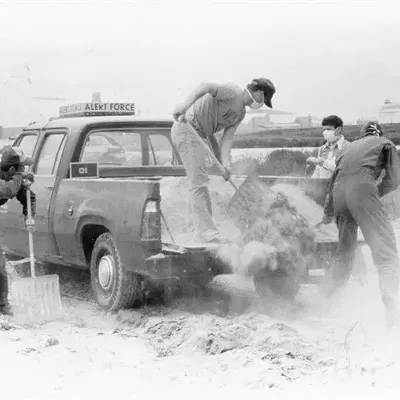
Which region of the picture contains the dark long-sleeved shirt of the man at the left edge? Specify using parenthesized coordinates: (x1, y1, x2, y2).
(0, 170, 36, 217)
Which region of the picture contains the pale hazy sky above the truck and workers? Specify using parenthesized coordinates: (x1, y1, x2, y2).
(0, 0, 400, 126)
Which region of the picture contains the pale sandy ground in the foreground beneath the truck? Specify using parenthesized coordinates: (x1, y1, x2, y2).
(0, 245, 400, 399)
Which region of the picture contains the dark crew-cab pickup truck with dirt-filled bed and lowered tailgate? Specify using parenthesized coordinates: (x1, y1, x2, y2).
(0, 110, 348, 311)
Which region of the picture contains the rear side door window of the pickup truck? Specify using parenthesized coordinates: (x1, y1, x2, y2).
(36, 133, 66, 175)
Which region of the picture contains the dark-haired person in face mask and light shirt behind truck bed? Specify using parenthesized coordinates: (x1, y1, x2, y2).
(306, 115, 349, 178)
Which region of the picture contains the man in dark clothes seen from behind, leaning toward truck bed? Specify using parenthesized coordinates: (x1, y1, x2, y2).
(324, 122, 400, 326)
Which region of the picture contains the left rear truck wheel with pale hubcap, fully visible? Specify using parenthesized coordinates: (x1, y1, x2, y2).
(90, 232, 141, 312)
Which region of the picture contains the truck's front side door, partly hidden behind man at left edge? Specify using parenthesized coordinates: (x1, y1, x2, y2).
(0, 131, 39, 255)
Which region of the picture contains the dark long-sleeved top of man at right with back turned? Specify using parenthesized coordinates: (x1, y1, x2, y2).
(324, 135, 400, 216)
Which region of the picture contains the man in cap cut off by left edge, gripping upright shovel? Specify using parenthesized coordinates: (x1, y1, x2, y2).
(0, 146, 36, 315)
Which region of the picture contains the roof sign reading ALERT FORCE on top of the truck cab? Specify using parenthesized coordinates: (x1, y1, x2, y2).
(60, 103, 135, 118)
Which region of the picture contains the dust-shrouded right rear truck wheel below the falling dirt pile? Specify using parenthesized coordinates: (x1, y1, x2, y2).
(253, 269, 300, 302)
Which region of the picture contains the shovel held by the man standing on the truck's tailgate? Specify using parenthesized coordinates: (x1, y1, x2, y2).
(182, 123, 277, 231)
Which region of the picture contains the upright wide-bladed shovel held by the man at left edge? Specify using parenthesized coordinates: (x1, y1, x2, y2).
(11, 189, 62, 322)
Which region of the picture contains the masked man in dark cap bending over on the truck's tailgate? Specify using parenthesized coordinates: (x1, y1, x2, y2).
(172, 78, 275, 244)
